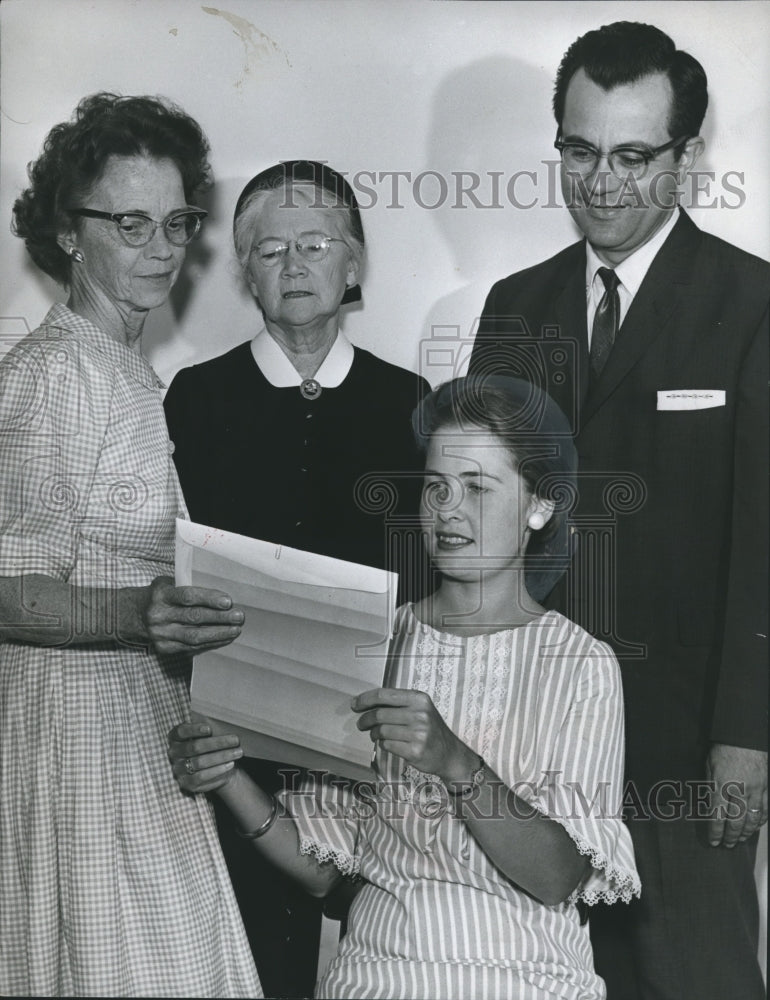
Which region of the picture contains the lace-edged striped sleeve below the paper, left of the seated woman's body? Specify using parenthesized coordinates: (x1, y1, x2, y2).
(276, 771, 366, 876)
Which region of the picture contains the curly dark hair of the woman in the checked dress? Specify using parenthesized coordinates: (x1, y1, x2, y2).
(11, 91, 211, 285)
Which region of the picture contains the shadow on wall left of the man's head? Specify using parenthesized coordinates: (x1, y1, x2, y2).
(420, 56, 569, 385)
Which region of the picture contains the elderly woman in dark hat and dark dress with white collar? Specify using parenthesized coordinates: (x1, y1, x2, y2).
(165, 160, 428, 996)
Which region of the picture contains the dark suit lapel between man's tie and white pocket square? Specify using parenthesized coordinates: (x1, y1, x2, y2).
(580, 212, 700, 427)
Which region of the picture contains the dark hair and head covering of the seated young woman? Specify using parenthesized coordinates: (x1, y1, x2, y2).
(412, 375, 577, 600)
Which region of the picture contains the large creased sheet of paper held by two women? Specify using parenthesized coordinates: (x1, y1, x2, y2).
(176, 520, 397, 779)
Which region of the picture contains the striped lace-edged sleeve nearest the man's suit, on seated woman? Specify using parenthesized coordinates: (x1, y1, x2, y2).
(520, 642, 641, 904)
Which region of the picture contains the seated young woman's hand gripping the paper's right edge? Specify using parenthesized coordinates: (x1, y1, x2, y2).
(351, 688, 478, 782)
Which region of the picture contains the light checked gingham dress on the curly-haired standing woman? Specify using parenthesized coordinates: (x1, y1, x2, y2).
(0, 305, 261, 997)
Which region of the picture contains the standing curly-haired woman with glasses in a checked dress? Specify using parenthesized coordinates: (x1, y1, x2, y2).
(0, 93, 261, 997)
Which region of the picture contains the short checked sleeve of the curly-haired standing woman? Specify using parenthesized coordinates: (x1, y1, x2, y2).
(0, 329, 113, 581)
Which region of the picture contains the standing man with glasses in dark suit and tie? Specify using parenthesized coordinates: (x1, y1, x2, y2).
(470, 22, 770, 1000)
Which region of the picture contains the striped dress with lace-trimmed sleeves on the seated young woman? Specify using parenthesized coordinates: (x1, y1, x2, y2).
(286, 605, 640, 1000)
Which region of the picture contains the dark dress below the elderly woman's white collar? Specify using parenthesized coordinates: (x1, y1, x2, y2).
(165, 342, 429, 997)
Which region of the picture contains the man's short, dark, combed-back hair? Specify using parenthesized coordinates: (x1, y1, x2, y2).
(553, 21, 708, 150)
